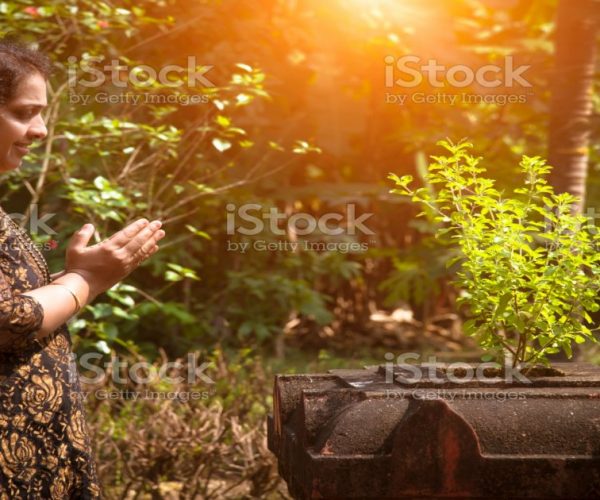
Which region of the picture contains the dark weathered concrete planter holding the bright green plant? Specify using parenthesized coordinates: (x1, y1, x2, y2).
(269, 363, 600, 499)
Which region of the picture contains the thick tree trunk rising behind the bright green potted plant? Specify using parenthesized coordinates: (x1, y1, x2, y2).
(548, 0, 600, 213)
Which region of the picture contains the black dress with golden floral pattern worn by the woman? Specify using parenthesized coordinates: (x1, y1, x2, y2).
(0, 209, 100, 500)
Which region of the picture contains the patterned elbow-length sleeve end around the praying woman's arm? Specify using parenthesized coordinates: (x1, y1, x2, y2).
(0, 271, 44, 351)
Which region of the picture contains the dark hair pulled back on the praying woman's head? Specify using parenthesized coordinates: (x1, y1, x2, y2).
(0, 39, 52, 106)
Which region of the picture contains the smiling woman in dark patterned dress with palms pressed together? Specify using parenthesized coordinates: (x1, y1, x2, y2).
(0, 40, 164, 500)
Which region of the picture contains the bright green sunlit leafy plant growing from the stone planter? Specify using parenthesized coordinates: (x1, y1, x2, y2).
(390, 141, 600, 365)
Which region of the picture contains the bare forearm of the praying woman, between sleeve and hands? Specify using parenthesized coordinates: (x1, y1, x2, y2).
(23, 273, 95, 338)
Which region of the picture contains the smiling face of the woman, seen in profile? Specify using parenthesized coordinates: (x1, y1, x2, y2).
(0, 73, 48, 172)
